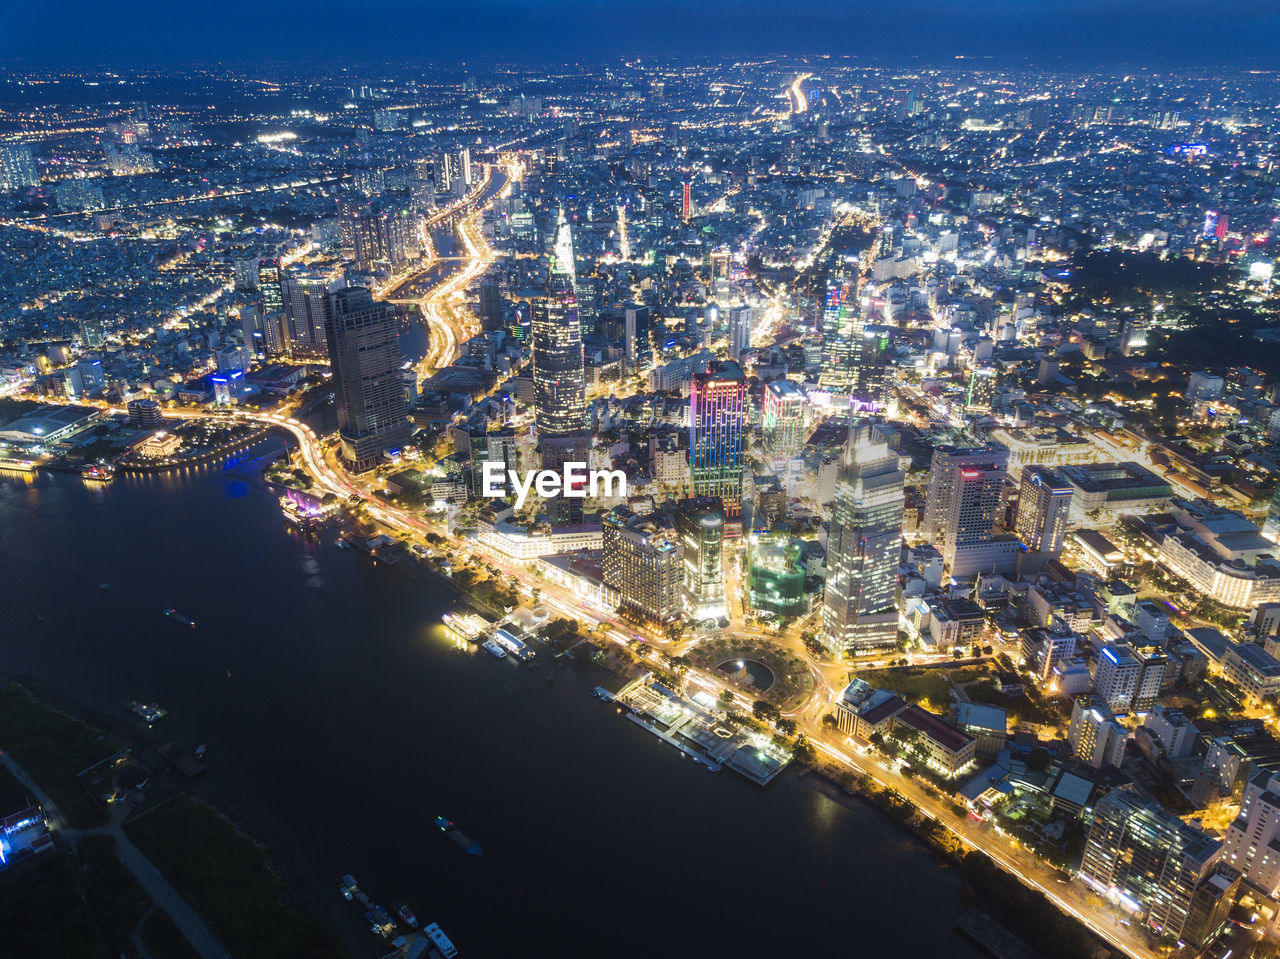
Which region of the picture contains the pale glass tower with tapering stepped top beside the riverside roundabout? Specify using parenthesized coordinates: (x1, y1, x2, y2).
(822, 424, 905, 656)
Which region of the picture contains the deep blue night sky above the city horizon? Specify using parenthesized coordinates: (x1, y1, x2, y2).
(0, 0, 1280, 70)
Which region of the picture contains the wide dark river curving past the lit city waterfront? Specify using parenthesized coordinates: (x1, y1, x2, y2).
(0, 465, 977, 959)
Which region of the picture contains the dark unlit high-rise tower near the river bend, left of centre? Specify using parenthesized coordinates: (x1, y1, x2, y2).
(328, 287, 411, 472)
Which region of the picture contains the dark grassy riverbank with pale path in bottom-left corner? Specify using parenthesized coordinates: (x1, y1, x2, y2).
(0, 677, 344, 959)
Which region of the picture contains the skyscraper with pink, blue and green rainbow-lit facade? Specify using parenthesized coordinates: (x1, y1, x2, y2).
(689, 360, 746, 520)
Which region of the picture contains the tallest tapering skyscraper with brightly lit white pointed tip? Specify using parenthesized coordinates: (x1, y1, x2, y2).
(532, 210, 586, 439)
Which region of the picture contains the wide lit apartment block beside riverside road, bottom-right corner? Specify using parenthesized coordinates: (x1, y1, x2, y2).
(1080, 786, 1222, 939)
